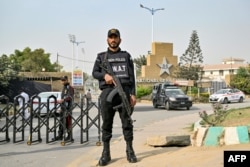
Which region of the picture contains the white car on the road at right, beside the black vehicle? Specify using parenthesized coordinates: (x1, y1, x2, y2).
(209, 88, 245, 104)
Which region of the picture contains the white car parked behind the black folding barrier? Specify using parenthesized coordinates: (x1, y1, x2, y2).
(32, 92, 61, 115)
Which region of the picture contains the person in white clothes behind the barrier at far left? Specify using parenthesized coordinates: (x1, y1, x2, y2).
(18, 87, 30, 120)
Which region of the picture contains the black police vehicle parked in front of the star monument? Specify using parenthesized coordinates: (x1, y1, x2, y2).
(152, 83, 193, 110)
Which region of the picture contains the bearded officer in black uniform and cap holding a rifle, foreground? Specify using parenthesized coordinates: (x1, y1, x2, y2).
(92, 29, 137, 166)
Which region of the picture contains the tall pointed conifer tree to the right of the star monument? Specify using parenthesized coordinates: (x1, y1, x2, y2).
(175, 30, 203, 84)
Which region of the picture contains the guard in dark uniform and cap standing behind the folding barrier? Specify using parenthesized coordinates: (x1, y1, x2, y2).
(52, 76, 74, 140)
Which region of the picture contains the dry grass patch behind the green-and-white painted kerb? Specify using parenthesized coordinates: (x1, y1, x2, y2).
(201, 107, 250, 127)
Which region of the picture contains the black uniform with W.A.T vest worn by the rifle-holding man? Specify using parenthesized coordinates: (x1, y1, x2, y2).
(92, 49, 135, 142)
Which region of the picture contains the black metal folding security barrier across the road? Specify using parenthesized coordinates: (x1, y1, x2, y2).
(0, 95, 101, 146)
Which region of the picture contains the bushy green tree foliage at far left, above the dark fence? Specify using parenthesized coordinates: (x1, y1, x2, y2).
(0, 47, 62, 86)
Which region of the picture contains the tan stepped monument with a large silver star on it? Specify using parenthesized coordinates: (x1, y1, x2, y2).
(137, 42, 193, 86)
